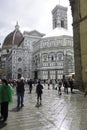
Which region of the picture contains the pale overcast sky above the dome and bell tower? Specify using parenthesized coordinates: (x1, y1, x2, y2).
(0, 0, 72, 46)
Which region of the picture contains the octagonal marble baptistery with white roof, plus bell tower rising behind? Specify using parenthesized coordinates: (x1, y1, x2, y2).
(32, 5, 74, 79)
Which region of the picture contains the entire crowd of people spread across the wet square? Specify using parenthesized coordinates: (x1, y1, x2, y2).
(0, 78, 74, 125)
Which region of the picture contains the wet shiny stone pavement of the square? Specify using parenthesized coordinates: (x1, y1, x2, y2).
(0, 85, 87, 130)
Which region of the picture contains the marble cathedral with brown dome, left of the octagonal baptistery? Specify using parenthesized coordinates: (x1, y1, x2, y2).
(1, 23, 44, 79)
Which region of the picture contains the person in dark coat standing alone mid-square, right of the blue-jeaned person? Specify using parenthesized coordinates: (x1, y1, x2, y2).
(36, 81, 43, 105)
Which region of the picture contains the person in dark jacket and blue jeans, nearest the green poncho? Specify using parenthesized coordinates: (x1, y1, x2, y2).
(16, 79, 25, 108)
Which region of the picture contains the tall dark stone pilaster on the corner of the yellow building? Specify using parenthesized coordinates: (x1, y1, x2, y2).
(69, 0, 83, 90)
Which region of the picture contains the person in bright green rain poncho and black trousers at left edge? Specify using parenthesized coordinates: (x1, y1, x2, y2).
(0, 79, 14, 123)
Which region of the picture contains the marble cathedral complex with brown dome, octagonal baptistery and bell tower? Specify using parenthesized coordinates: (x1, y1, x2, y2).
(1, 5, 74, 80)
